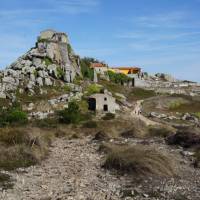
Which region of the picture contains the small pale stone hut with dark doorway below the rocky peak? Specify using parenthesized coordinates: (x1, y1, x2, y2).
(88, 92, 119, 113)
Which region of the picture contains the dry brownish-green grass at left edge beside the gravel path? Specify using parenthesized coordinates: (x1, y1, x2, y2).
(0, 128, 54, 170)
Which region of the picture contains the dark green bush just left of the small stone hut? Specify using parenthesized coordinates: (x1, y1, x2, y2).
(59, 101, 81, 124)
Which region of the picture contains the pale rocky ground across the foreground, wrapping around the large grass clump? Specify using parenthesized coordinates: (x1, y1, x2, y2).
(0, 137, 200, 200)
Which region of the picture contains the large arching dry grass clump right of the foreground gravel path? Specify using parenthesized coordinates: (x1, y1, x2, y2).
(103, 145, 176, 177)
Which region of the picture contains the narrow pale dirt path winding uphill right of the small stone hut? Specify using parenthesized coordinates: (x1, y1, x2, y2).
(131, 100, 159, 126)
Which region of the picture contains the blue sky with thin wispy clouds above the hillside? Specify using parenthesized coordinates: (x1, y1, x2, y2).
(0, 0, 200, 82)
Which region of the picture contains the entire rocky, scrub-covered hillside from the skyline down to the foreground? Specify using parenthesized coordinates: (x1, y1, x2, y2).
(0, 30, 200, 200)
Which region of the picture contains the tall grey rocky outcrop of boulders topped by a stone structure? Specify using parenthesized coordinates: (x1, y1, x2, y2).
(0, 30, 81, 98)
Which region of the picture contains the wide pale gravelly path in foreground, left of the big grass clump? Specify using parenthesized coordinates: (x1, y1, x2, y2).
(0, 138, 120, 200)
